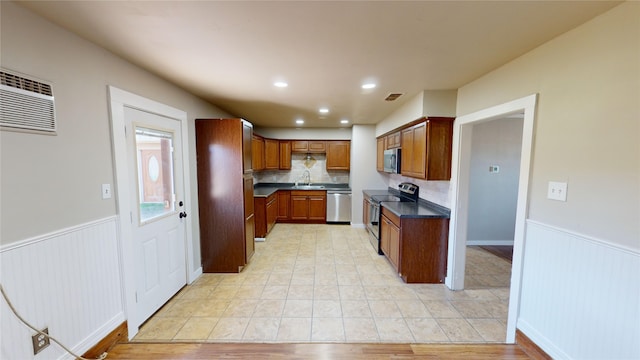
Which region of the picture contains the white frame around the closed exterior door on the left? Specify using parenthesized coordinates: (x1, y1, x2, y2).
(108, 86, 197, 340)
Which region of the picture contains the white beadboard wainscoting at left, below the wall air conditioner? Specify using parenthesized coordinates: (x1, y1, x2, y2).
(0, 217, 125, 360)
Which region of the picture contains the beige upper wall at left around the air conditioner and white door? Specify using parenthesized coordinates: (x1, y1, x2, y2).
(0, 1, 228, 253)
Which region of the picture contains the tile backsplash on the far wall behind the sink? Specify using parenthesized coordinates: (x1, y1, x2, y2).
(253, 153, 349, 184)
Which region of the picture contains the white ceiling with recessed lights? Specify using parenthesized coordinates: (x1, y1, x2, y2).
(19, 1, 620, 127)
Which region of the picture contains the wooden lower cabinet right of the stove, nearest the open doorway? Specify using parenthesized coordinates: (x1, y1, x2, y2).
(380, 207, 449, 284)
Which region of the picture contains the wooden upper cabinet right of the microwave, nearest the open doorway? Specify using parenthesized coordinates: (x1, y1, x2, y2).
(400, 118, 454, 180)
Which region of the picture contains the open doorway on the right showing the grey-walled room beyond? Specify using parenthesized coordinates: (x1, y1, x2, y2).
(464, 112, 524, 293)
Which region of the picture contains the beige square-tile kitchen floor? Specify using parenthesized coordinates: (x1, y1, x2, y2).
(134, 224, 511, 343)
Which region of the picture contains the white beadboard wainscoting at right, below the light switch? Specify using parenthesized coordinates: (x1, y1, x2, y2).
(517, 221, 640, 359)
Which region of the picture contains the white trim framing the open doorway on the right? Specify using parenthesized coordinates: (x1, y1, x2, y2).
(445, 94, 538, 343)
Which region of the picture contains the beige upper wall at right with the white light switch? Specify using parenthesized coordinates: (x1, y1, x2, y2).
(457, 2, 640, 249)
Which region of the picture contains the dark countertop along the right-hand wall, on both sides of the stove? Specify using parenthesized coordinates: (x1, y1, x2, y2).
(362, 189, 451, 219)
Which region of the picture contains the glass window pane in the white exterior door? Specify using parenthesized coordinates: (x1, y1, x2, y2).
(136, 127, 175, 223)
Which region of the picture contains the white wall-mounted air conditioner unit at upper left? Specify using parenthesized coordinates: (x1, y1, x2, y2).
(0, 69, 56, 134)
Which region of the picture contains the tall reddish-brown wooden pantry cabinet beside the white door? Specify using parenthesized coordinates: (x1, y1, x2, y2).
(195, 119, 255, 273)
